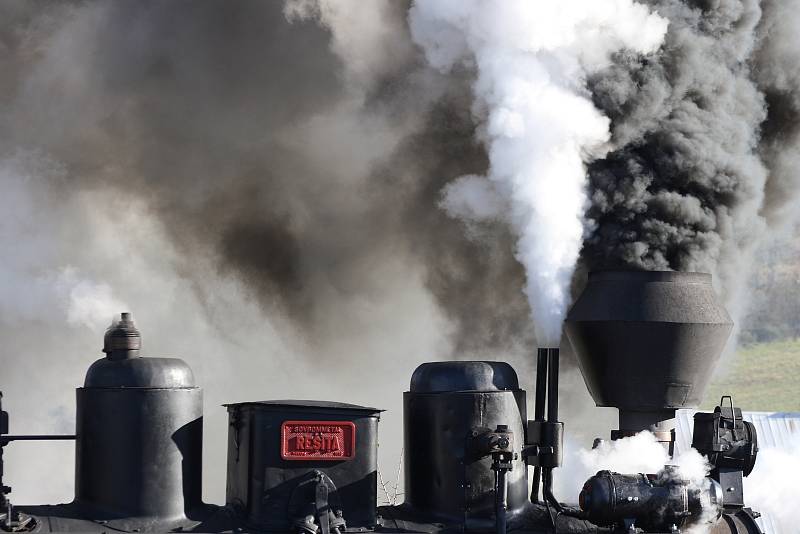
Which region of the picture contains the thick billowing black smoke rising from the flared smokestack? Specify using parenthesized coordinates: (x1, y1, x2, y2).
(583, 0, 800, 318)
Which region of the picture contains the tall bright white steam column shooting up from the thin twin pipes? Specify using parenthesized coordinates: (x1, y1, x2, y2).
(409, 0, 667, 344)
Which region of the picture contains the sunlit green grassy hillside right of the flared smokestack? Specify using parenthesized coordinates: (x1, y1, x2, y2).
(702, 340, 800, 412)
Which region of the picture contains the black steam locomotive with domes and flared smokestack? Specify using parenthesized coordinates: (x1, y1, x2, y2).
(0, 271, 760, 534)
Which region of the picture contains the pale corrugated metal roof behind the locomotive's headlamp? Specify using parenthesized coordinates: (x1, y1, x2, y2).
(675, 410, 800, 534)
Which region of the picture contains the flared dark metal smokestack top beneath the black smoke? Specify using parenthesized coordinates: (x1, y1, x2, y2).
(565, 271, 733, 411)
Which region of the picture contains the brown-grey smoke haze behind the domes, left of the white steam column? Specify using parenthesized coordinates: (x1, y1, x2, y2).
(0, 1, 544, 502)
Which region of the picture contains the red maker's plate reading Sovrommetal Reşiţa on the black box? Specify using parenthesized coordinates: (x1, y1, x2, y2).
(281, 421, 356, 460)
